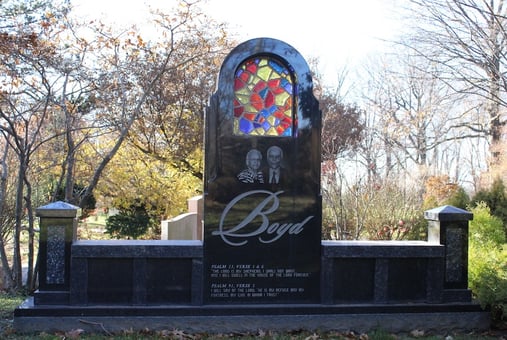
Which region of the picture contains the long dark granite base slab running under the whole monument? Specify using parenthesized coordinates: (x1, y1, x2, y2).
(14, 298, 490, 333)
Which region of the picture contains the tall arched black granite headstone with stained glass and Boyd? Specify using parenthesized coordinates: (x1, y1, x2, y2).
(203, 38, 322, 303)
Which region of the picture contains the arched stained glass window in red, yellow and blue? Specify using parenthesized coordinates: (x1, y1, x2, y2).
(234, 57, 295, 137)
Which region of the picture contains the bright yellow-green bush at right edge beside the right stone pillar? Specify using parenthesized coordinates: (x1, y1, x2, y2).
(468, 202, 507, 319)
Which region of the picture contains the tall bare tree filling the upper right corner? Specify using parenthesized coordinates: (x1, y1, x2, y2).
(404, 0, 507, 163)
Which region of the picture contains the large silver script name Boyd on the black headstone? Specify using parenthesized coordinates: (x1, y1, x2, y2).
(212, 190, 313, 246)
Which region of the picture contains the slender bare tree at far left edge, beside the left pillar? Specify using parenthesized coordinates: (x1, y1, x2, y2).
(0, 1, 70, 288)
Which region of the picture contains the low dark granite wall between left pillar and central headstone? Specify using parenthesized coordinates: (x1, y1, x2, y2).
(70, 240, 203, 305)
